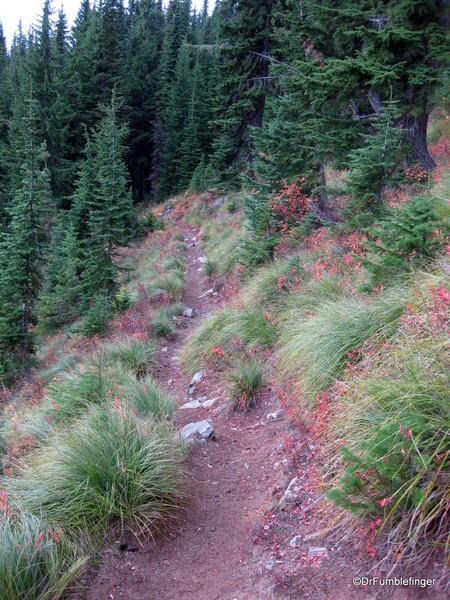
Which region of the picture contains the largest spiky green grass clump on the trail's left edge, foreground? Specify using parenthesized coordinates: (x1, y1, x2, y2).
(1, 402, 185, 536)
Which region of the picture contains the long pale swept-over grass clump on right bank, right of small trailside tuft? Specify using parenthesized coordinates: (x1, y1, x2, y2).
(279, 293, 405, 396)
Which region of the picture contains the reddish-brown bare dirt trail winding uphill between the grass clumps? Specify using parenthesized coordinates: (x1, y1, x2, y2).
(87, 223, 446, 600)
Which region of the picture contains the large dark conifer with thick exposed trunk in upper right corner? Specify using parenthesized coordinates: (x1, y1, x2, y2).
(300, 0, 450, 169)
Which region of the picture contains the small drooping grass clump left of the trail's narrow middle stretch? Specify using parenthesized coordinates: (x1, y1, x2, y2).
(105, 336, 157, 375)
